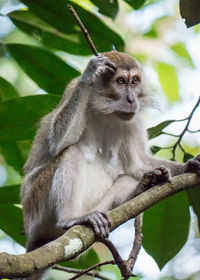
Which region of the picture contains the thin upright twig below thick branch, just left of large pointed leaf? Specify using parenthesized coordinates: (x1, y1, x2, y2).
(126, 215, 143, 271)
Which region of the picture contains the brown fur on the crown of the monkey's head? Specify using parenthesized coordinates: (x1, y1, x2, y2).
(103, 51, 141, 70)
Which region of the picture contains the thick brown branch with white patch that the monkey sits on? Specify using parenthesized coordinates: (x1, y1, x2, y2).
(0, 173, 200, 278)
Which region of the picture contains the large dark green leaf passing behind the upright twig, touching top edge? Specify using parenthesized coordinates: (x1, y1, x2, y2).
(19, 0, 124, 52)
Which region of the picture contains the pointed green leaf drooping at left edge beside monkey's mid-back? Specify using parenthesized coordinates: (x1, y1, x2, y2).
(0, 140, 25, 175)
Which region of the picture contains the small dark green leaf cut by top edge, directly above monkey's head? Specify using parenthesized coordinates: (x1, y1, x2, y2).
(91, 0, 119, 19)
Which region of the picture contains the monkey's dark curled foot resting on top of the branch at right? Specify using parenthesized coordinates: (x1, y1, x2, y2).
(142, 167, 170, 189)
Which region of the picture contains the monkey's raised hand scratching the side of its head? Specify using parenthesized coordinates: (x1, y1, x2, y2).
(81, 55, 117, 86)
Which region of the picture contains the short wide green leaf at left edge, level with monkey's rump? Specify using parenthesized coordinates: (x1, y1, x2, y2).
(0, 185, 20, 204)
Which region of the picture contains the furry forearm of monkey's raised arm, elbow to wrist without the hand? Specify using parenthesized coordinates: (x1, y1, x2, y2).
(49, 77, 90, 156)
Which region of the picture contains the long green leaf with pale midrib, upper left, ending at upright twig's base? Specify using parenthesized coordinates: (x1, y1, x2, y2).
(8, 10, 91, 55)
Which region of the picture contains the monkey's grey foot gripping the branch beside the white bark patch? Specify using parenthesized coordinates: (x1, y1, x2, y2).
(61, 211, 111, 239)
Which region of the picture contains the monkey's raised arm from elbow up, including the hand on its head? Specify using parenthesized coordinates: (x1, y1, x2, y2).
(49, 56, 116, 156)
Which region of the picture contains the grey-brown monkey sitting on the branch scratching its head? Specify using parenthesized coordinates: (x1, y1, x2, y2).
(21, 51, 200, 279)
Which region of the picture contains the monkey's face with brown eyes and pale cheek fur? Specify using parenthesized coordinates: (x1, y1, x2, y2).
(92, 67, 142, 120)
